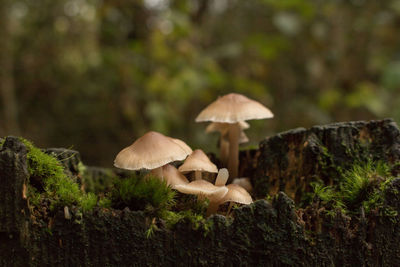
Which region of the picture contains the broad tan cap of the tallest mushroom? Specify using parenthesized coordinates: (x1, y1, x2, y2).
(196, 93, 274, 123)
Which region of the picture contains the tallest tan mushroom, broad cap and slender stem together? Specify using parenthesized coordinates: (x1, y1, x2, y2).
(196, 93, 274, 178)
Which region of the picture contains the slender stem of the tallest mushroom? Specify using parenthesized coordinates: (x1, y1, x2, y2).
(228, 123, 240, 180)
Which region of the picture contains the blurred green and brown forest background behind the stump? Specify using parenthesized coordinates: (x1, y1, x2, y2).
(0, 0, 400, 166)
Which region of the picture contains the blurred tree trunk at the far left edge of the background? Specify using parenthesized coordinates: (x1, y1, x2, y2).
(0, 1, 20, 135)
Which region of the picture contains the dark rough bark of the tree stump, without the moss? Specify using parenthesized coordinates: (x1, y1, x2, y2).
(0, 120, 400, 266)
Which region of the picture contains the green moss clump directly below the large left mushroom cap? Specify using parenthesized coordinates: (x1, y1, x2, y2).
(111, 176, 175, 214)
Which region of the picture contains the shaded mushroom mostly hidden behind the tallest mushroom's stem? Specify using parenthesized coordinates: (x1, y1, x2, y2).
(206, 121, 250, 165)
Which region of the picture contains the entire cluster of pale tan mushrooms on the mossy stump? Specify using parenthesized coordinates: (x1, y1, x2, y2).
(114, 93, 273, 216)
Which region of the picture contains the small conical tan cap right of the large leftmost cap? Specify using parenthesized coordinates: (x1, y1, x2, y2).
(179, 149, 218, 173)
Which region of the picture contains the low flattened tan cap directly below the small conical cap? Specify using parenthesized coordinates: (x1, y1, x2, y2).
(175, 180, 228, 201)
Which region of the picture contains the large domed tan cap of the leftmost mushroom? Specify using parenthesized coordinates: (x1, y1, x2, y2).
(114, 131, 190, 170)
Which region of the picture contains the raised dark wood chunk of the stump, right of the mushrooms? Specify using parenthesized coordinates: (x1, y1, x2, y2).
(253, 120, 400, 202)
